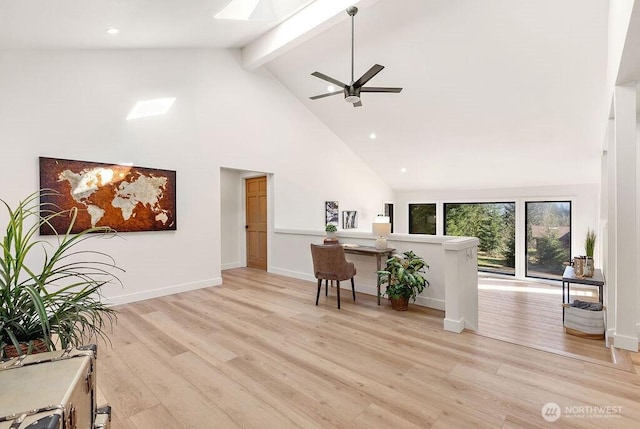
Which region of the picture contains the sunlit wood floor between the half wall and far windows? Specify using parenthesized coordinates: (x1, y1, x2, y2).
(478, 277, 611, 362)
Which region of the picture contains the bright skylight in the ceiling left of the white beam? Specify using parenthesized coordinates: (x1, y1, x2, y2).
(214, 0, 315, 22)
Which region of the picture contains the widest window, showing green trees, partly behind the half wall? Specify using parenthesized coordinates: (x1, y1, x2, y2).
(444, 202, 516, 275)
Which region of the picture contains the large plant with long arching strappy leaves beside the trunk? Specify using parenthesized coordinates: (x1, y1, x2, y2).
(0, 189, 123, 358)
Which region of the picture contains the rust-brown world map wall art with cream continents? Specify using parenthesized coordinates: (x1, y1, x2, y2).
(40, 157, 176, 235)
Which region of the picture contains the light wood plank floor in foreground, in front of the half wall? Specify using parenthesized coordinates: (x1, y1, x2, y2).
(98, 269, 640, 429)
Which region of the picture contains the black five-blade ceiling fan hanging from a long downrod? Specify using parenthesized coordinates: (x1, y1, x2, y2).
(309, 6, 402, 107)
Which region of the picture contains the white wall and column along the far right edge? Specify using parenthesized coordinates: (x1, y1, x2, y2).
(601, 0, 640, 351)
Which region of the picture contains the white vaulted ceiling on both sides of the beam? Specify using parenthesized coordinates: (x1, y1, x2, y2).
(0, 0, 608, 189)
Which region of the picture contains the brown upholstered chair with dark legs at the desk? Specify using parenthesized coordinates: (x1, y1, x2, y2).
(311, 243, 356, 308)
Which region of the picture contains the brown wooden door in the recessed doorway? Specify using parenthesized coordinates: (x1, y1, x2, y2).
(246, 176, 267, 271)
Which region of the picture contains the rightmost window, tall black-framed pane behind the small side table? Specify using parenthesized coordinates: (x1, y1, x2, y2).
(525, 201, 571, 280)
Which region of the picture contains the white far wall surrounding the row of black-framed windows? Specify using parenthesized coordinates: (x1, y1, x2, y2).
(394, 184, 601, 278)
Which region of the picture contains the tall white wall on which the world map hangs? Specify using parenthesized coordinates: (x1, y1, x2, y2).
(0, 49, 391, 302)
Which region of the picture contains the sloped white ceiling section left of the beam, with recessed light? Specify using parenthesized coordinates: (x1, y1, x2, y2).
(0, 0, 310, 49)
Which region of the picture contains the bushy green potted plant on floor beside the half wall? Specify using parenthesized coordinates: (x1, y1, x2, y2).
(378, 250, 429, 311)
